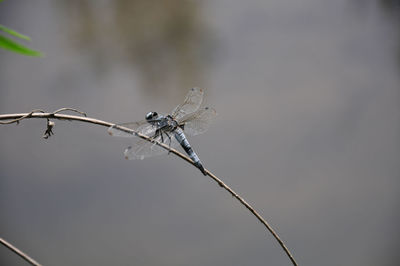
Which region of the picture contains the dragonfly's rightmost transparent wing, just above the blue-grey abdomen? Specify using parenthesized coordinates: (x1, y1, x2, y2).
(178, 107, 217, 136)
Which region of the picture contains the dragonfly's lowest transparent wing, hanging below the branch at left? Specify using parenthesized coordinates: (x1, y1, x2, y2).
(124, 133, 179, 160)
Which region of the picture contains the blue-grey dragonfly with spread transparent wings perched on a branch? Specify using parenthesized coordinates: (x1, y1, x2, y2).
(108, 87, 217, 175)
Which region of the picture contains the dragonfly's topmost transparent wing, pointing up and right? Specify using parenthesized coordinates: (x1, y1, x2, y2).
(171, 88, 204, 120)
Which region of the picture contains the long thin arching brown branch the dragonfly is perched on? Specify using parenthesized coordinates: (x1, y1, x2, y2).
(0, 108, 298, 266)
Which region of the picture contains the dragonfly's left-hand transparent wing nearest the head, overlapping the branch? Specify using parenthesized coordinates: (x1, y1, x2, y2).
(107, 120, 156, 138)
